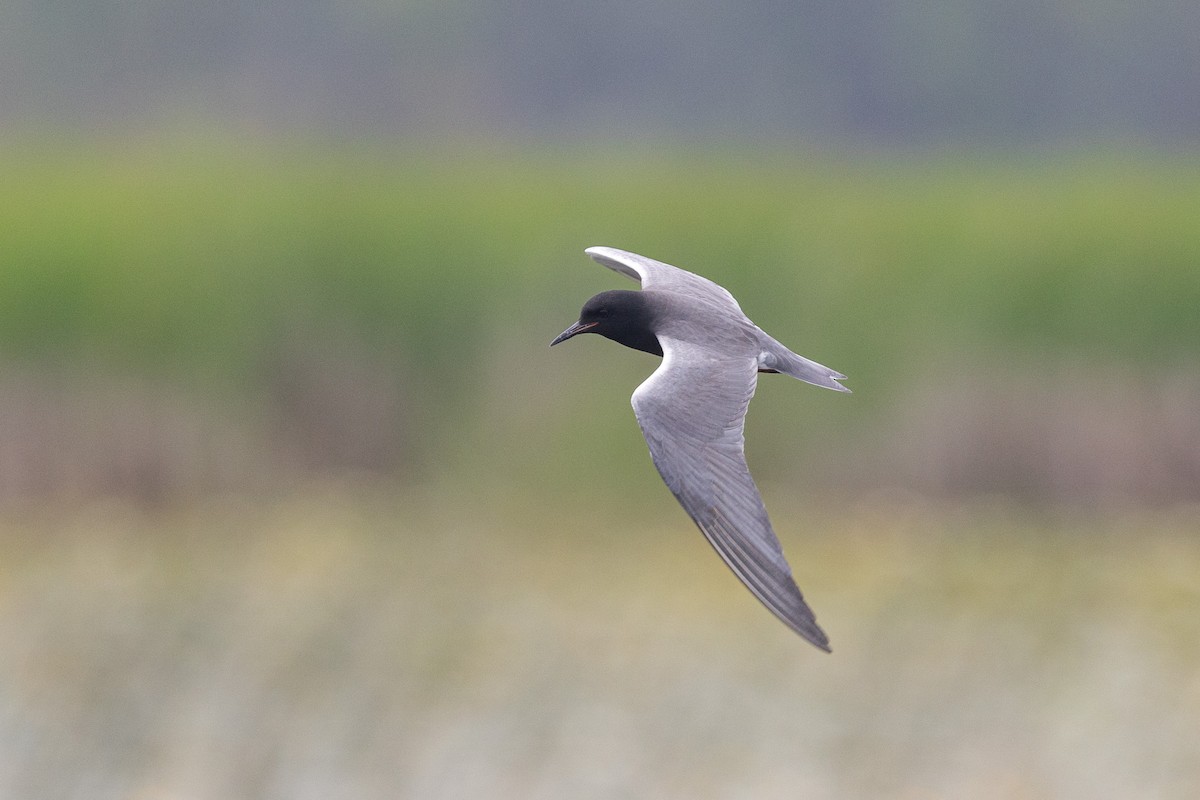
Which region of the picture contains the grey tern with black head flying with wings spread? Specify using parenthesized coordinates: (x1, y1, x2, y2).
(550, 247, 850, 652)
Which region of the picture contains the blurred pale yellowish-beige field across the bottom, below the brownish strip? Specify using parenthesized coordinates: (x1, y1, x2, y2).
(0, 489, 1200, 800)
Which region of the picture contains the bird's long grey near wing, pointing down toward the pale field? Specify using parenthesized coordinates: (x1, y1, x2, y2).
(632, 336, 829, 650)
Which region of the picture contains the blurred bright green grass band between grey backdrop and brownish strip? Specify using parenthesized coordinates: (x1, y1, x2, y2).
(0, 145, 1200, 373)
